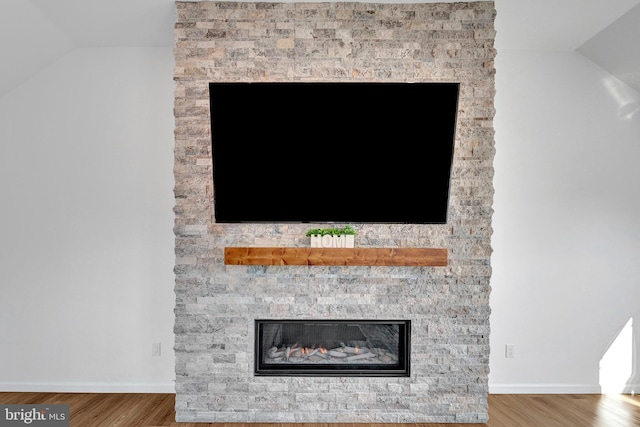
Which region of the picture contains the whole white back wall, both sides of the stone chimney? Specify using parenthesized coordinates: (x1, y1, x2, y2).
(0, 41, 640, 393)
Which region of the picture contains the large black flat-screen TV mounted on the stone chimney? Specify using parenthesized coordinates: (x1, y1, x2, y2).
(209, 82, 459, 224)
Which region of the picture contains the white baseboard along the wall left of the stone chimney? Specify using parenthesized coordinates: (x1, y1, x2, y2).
(0, 382, 176, 394)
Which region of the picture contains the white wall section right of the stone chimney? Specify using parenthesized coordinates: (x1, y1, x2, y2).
(489, 51, 640, 393)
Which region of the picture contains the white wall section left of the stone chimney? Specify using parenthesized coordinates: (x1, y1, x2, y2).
(0, 48, 175, 392)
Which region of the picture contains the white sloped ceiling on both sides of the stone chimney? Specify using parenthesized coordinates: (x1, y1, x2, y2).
(0, 0, 640, 97)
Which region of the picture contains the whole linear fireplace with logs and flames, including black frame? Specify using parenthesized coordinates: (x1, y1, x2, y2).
(255, 320, 411, 377)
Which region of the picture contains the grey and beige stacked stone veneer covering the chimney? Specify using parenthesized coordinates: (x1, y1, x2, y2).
(174, 2, 496, 423)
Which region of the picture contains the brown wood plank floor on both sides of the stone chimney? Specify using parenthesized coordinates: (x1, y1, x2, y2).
(0, 393, 640, 427)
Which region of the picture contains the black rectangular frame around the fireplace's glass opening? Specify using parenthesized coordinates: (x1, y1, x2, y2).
(254, 319, 411, 377)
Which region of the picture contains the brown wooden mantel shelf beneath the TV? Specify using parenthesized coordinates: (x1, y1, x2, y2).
(224, 247, 448, 267)
